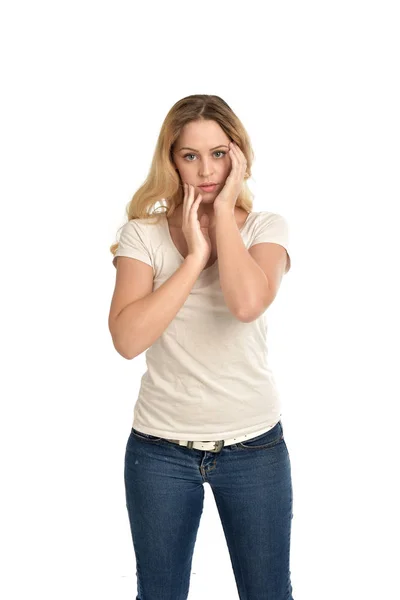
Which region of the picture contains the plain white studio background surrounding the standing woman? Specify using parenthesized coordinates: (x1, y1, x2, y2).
(0, 0, 400, 600)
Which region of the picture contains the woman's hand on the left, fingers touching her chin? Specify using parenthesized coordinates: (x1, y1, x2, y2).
(182, 183, 212, 266)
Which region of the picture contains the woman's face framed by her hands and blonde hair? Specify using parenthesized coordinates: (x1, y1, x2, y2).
(173, 121, 232, 204)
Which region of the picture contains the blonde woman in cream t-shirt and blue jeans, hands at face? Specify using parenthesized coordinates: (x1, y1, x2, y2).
(109, 95, 293, 600)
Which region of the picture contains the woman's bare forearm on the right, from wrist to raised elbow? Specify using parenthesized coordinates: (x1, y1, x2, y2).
(215, 210, 268, 320)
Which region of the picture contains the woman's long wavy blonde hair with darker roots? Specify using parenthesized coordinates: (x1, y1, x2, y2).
(110, 94, 254, 254)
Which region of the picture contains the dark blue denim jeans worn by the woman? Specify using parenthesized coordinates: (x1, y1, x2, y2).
(124, 421, 293, 600)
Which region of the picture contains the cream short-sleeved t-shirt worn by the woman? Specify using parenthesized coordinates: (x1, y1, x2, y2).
(113, 211, 290, 441)
